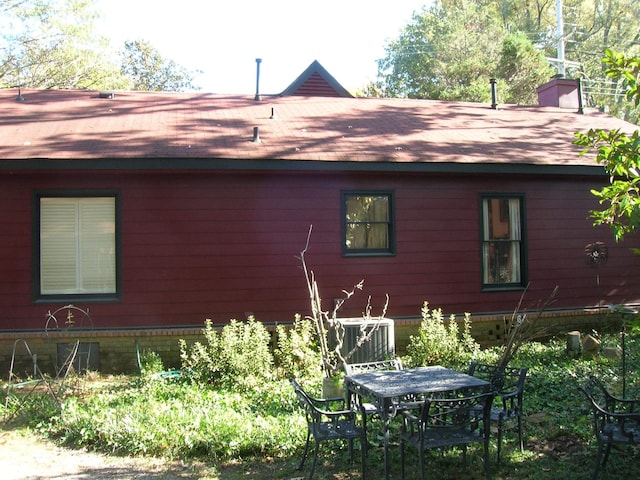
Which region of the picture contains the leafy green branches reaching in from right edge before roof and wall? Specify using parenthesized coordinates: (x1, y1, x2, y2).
(574, 50, 640, 241)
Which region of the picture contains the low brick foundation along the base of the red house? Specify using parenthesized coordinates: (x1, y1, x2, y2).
(0, 308, 620, 379)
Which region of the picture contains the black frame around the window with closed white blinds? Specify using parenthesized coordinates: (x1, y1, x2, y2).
(31, 189, 122, 303)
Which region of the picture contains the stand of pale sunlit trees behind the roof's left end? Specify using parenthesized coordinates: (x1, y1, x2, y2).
(0, 0, 200, 90)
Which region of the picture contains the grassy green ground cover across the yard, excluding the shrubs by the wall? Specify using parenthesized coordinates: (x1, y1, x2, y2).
(0, 335, 640, 480)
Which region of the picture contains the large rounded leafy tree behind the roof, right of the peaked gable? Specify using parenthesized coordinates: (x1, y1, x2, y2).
(378, 0, 551, 104)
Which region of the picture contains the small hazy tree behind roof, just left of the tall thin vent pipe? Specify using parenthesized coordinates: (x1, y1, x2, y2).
(121, 40, 198, 91)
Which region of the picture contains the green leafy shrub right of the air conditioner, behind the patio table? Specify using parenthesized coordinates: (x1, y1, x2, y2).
(405, 302, 480, 368)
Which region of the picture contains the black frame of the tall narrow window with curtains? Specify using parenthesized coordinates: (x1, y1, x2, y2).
(479, 192, 529, 291)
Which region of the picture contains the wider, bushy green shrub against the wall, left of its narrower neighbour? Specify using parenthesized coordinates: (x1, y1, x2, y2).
(180, 317, 273, 390)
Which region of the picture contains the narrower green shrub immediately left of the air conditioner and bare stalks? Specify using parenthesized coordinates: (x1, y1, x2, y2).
(274, 315, 322, 379)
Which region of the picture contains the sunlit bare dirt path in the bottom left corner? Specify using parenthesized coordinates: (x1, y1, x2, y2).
(0, 430, 218, 480)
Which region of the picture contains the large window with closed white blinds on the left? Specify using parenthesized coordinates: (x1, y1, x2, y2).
(40, 197, 116, 295)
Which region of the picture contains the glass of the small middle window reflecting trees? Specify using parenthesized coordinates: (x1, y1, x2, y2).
(345, 195, 390, 250)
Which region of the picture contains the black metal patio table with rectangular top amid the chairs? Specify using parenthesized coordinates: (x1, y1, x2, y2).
(345, 365, 490, 479)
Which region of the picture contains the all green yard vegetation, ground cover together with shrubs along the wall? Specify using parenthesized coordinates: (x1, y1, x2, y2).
(0, 310, 640, 480)
